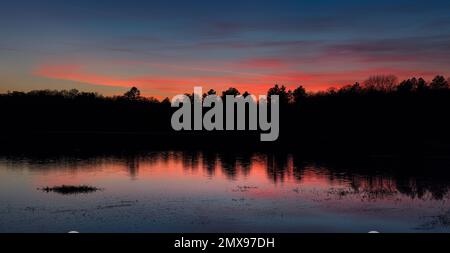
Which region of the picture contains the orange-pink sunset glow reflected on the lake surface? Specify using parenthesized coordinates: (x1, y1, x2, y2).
(25, 152, 450, 203)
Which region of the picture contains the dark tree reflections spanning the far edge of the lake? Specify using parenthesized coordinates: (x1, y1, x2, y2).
(0, 151, 450, 200)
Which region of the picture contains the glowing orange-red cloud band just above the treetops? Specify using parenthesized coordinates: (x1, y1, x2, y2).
(34, 60, 438, 99)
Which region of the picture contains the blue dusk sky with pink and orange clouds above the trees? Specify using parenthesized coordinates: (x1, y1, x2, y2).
(0, 0, 450, 98)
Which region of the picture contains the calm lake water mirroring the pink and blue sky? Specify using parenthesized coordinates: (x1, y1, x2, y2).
(0, 151, 450, 233)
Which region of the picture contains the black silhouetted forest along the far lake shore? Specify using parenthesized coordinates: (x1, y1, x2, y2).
(0, 75, 450, 153)
